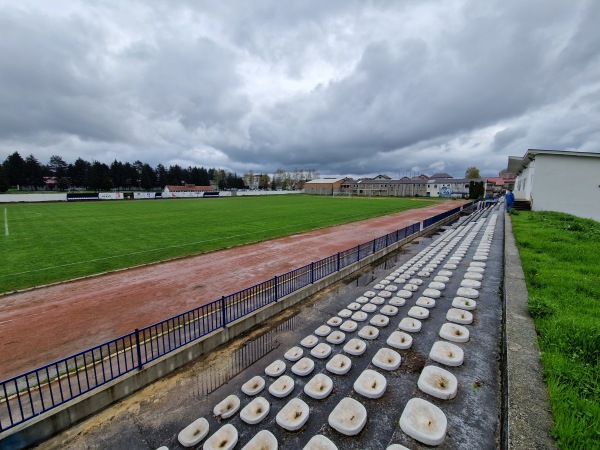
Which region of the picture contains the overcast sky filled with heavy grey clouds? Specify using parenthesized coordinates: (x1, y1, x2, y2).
(0, 0, 600, 178)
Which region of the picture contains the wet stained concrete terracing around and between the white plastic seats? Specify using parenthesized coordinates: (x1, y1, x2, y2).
(34, 211, 503, 449)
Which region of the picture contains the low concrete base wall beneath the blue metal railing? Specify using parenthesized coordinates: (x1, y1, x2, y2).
(0, 213, 460, 449)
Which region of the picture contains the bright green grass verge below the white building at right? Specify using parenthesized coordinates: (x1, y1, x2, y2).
(512, 212, 600, 449)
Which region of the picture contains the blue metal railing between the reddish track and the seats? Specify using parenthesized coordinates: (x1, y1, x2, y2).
(0, 203, 473, 432)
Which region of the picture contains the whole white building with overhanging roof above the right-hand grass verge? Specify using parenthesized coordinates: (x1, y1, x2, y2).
(508, 149, 600, 221)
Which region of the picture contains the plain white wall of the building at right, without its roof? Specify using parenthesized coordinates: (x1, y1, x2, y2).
(522, 154, 600, 221)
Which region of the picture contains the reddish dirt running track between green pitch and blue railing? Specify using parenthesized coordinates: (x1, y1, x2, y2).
(0, 202, 459, 379)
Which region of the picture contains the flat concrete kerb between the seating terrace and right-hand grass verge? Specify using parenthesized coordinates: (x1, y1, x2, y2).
(504, 214, 556, 450)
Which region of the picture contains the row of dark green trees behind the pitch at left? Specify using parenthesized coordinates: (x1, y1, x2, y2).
(0, 152, 247, 192)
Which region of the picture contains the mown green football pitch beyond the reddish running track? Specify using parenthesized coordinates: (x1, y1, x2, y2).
(0, 195, 435, 292)
